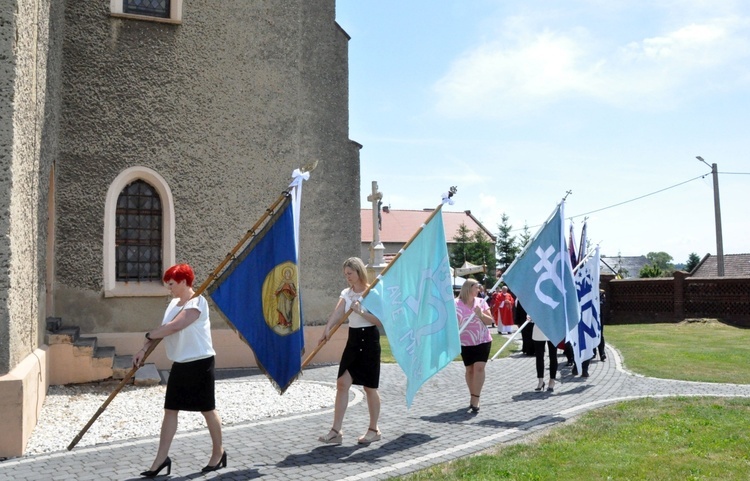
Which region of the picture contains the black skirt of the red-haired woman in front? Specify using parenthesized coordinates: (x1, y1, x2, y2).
(164, 356, 216, 412)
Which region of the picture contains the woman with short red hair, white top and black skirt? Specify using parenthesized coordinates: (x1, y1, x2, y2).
(133, 264, 227, 478)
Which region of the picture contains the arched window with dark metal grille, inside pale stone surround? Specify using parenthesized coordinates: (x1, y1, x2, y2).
(115, 179, 163, 282)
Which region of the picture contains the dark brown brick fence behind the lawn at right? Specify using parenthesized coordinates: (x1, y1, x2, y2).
(601, 271, 750, 327)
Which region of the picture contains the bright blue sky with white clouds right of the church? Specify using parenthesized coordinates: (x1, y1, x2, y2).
(336, 0, 750, 263)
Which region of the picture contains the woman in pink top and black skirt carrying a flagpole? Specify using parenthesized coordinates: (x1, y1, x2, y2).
(456, 279, 493, 414)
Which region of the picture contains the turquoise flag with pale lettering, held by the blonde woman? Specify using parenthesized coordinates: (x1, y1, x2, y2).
(362, 212, 461, 407)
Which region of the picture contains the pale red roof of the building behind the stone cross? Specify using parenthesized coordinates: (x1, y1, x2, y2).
(359, 209, 496, 244)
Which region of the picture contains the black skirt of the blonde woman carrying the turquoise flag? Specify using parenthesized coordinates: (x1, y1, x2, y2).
(338, 326, 380, 389)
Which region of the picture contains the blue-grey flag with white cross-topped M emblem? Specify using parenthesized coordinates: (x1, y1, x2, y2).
(503, 202, 580, 344)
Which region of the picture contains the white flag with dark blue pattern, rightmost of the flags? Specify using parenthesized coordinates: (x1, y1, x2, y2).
(568, 246, 602, 372)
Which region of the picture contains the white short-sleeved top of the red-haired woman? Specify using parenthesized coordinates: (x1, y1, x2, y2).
(161, 296, 216, 362)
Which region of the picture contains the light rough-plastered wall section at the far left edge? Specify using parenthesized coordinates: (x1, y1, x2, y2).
(0, 0, 62, 374)
